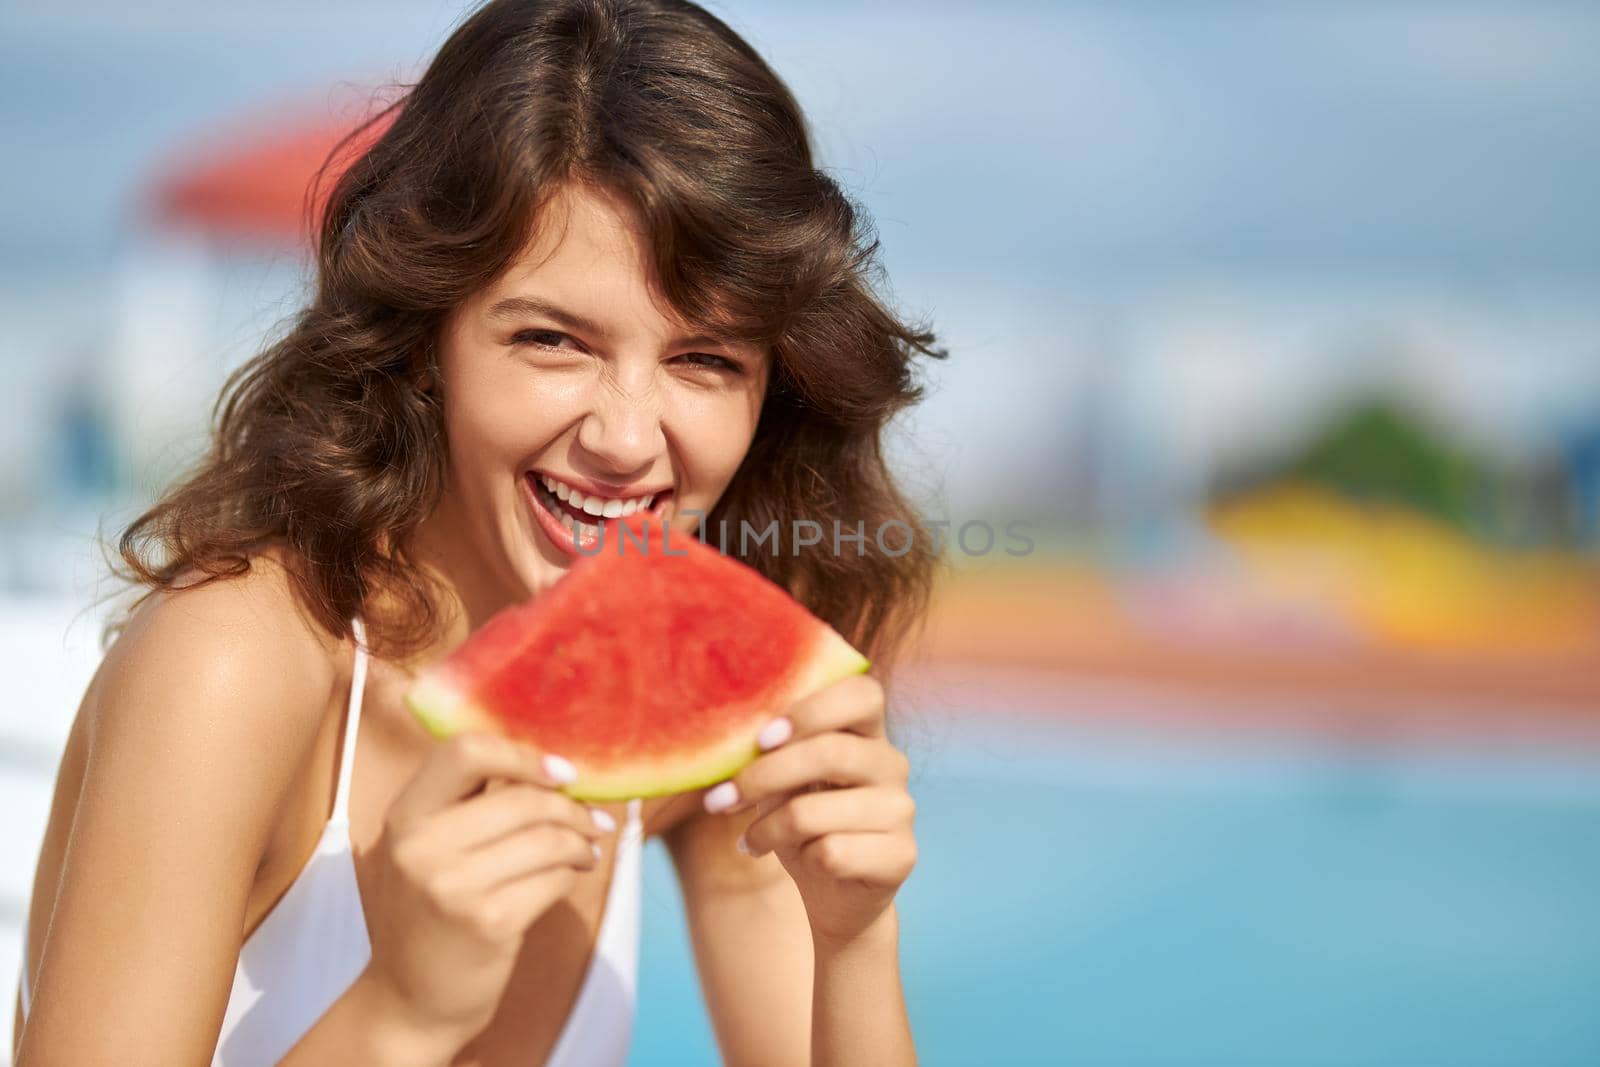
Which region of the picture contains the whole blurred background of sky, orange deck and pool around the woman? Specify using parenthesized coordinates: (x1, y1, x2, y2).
(0, 0, 1600, 1067)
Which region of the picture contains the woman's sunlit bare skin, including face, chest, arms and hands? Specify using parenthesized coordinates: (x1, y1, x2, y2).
(3, 179, 915, 1067)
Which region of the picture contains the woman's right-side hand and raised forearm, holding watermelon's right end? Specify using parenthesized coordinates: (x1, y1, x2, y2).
(666, 678, 915, 1067)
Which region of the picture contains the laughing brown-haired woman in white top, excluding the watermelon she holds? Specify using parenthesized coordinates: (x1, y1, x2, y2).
(16, 0, 942, 1067)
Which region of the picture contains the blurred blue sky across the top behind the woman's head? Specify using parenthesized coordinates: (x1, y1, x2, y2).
(0, 0, 1600, 275)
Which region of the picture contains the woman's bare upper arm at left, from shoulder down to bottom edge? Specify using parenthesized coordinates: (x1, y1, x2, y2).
(18, 568, 333, 1067)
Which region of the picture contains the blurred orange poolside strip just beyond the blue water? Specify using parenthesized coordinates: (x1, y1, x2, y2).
(907, 558, 1600, 741)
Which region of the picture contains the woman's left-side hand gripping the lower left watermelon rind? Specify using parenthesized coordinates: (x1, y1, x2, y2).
(363, 733, 616, 1045)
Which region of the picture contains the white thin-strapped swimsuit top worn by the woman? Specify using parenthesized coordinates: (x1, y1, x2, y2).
(19, 619, 643, 1067)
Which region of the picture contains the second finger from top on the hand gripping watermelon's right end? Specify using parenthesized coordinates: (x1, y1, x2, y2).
(704, 729, 910, 811)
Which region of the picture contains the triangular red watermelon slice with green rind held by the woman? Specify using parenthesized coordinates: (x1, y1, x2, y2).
(405, 515, 870, 800)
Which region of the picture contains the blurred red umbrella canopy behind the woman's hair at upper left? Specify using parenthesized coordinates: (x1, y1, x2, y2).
(147, 93, 398, 246)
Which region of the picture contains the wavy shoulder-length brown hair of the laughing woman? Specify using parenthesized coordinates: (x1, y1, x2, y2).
(107, 0, 947, 684)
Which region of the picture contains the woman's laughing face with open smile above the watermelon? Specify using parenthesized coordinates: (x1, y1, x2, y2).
(429, 186, 771, 598)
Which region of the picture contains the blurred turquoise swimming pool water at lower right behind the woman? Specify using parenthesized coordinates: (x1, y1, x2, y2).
(630, 715, 1600, 1067)
